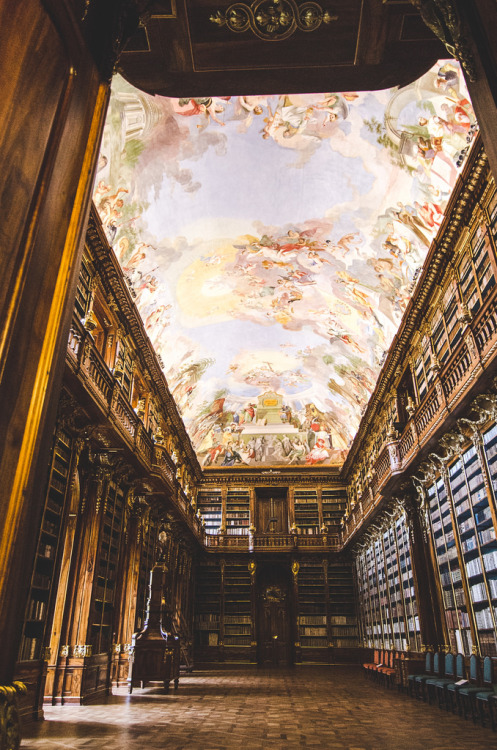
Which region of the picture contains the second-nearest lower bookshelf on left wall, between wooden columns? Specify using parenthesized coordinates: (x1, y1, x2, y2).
(90, 480, 124, 654)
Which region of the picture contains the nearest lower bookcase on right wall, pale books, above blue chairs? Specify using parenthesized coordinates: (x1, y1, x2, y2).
(427, 425, 497, 656)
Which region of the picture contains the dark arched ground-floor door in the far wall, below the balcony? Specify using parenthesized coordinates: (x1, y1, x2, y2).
(256, 561, 295, 667)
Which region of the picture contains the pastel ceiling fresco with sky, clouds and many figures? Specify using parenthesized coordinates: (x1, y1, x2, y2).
(94, 61, 476, 466)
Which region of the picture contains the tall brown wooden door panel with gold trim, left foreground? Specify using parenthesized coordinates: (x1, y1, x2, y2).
(0, 0, 108, 683)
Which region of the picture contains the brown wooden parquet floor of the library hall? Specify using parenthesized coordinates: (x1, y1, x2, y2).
(22, 666, 497, 750)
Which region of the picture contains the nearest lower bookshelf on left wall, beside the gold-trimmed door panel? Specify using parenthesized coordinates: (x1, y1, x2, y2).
(19, 431, 72, 661)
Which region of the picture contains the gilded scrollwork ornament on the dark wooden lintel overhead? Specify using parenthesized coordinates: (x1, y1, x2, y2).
(209, 0, 338, 42)
